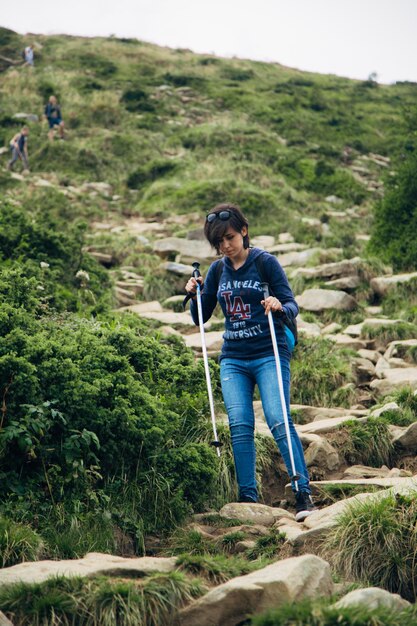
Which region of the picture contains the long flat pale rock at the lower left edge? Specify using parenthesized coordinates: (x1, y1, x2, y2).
(0, 552, 176, 586)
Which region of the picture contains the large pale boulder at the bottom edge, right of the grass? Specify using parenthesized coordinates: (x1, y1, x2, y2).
(180, 554, 333, 626)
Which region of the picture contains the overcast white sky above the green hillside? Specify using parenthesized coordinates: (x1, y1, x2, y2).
(0, 0, 417, 83)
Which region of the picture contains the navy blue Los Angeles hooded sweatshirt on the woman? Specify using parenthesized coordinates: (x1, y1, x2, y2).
(190, 248, 298, 359)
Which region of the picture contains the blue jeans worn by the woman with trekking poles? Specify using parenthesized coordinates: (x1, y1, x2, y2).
(220, 354, 311, 501)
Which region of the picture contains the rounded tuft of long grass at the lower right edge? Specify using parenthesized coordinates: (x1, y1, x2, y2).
(325, 493, 417, 600)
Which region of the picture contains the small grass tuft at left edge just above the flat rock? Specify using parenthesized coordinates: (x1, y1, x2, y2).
(0, 517, 45, 567)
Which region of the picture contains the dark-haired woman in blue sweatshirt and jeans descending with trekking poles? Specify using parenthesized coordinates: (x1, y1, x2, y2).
(185, 204, 316, 521)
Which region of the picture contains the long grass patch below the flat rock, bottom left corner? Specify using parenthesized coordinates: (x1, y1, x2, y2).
(0, 571, 205, 626)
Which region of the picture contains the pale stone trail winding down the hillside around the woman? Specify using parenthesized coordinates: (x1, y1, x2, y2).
(0, 182, 417, 626)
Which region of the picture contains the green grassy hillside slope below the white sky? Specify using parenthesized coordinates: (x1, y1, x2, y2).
(0, 25, 417, 239)
